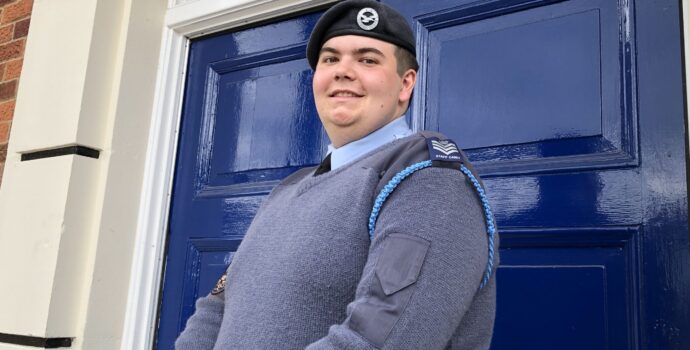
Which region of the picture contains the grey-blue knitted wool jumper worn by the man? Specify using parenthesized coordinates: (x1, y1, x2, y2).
(175, 133, 498, 350)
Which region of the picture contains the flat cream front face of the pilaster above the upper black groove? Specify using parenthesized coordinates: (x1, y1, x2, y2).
(3, 0, 98, 152)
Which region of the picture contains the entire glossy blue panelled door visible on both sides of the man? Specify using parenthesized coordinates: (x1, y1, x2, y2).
(158, 0, 690, 349)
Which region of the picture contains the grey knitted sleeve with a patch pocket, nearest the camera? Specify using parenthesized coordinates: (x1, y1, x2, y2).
(307, 167, 488, 350)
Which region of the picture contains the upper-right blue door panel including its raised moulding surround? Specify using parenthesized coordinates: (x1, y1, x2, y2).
(416, 0, 637, 175)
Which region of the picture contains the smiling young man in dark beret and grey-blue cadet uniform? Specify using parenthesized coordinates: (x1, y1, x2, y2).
(171, 0, 498, 350)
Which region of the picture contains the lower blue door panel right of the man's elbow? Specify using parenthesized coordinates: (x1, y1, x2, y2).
(492, 223, 639, 349)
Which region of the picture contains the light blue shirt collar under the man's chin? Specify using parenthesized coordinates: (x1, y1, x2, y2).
(328, 116, 412, 170)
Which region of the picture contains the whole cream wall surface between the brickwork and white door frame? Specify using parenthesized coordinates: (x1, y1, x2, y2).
(0, 0, 167, 349)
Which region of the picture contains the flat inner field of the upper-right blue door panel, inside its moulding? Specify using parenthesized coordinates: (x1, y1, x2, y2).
(436, 7, 602, 148)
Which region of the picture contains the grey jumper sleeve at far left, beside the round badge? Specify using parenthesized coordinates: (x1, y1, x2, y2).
(175, 273, 227, 350)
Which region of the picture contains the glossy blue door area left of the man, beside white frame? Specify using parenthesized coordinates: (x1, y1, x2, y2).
(157, 14, 328, 349)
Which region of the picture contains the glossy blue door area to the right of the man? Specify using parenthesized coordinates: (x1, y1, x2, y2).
(384, 0, 690, 349)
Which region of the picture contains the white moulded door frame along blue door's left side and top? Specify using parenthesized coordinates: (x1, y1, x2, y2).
(121, 0, 335, 350)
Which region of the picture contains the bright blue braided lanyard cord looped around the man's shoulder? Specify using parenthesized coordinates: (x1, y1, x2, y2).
(369, 160, 496, 289)
